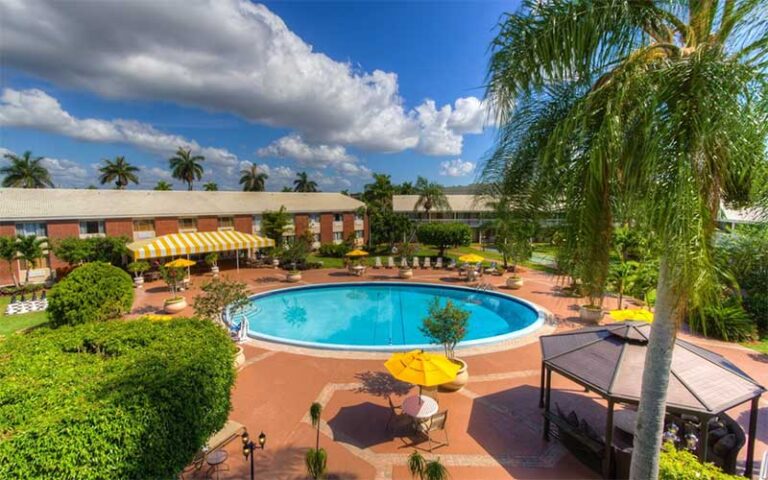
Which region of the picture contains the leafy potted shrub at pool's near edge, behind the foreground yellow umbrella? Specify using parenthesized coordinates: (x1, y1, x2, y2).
(419, 298, 469, 392)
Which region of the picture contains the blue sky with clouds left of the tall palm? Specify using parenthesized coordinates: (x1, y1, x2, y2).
(0, 0, 516, 192)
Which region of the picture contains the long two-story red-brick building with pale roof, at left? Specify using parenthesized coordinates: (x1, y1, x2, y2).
(0, 188, 368, 285)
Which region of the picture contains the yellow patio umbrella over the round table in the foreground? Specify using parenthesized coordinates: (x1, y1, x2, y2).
(384, 350, 461, 387)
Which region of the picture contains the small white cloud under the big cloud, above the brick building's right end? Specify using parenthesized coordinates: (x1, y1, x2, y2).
(256, 134, 371, 177)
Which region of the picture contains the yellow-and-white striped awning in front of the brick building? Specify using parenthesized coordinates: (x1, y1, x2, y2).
(128, 230, 275, 260)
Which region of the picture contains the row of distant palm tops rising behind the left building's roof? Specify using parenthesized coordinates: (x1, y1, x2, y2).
(0, 147, 319, 192)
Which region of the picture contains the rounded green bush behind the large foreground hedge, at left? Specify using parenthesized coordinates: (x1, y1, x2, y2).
(48, 262, 133, 326)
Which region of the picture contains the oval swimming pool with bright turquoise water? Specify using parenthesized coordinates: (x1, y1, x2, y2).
(237, 283, 544, 351)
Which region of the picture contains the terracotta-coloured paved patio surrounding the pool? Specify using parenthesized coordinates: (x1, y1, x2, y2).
(135, 269, 768, 480)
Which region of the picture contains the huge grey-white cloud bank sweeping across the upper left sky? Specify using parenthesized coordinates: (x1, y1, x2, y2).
(0, 0, 492, 155)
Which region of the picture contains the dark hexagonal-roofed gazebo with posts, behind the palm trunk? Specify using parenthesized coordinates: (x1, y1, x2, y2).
(539, 322, 765, 478)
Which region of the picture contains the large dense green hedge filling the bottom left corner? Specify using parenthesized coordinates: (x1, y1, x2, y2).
(0, 319, 235, 480)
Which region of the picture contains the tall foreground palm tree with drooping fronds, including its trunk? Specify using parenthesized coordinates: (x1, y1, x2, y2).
(483, 0, 768, 479)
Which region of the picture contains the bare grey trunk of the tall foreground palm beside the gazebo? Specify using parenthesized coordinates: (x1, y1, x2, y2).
(629, 256, 682, 480)
